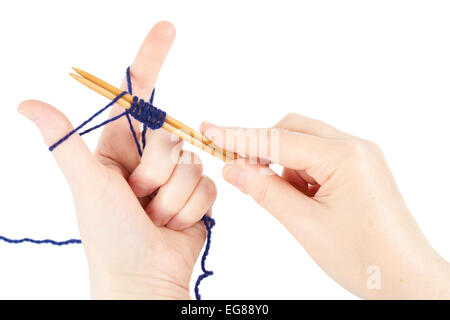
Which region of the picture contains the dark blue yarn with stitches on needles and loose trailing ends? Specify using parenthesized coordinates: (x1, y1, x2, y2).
(0, 67, 215, 300)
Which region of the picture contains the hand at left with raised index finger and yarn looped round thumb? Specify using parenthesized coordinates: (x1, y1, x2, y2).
(18, 22, 216, 299)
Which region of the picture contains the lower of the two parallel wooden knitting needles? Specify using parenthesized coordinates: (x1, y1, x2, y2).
(70, 73, 241, 161)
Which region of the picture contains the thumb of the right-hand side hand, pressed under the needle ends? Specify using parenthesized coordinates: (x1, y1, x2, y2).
(223, 162, 320, 230)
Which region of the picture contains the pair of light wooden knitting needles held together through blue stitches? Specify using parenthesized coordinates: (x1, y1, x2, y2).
(70, 68, 242, 161)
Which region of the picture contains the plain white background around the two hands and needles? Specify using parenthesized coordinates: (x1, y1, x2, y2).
(0, 0, 450, 299)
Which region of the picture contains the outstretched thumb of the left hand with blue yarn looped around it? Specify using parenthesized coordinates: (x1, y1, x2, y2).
(17, 100, 99, 193)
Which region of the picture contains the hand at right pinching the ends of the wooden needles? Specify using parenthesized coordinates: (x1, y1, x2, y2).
(201, 114, 450, 299)
